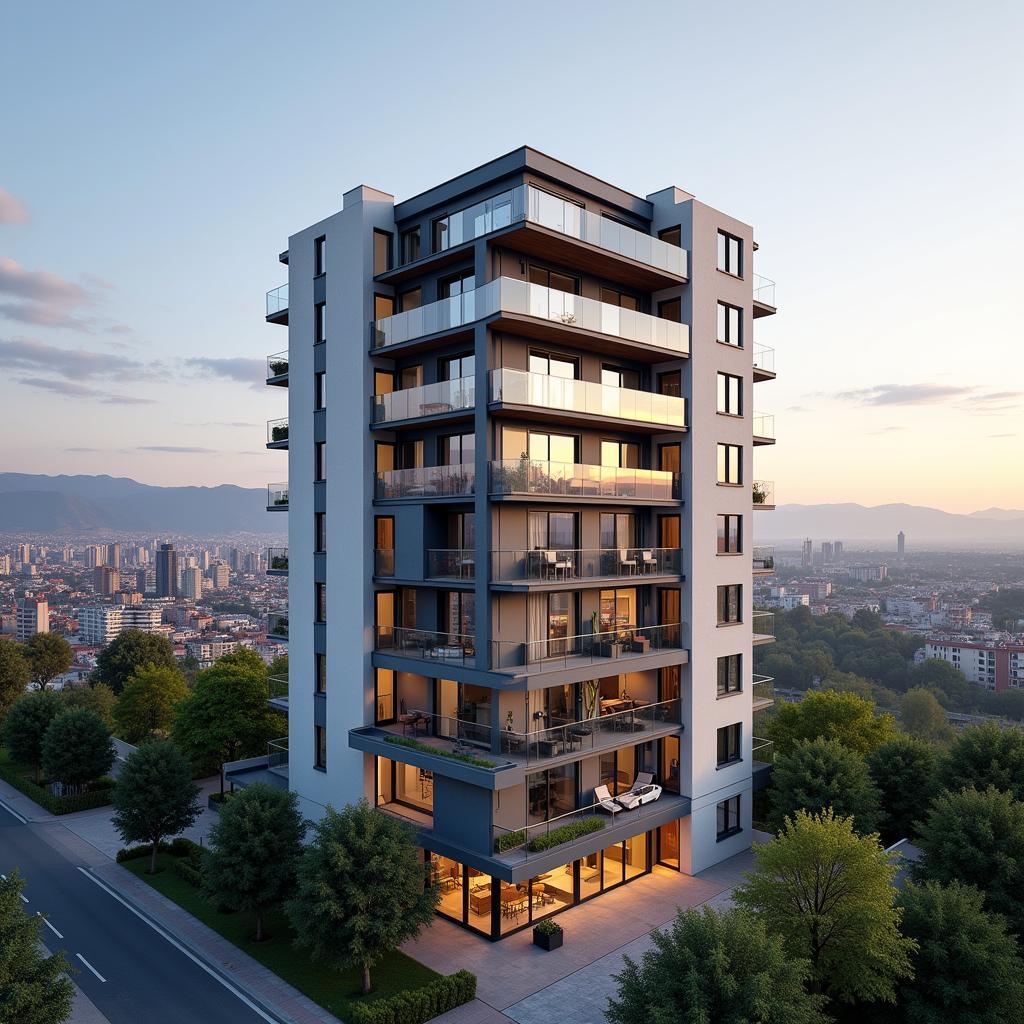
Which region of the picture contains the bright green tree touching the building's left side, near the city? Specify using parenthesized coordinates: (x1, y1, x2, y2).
(172, 649, 281, 771)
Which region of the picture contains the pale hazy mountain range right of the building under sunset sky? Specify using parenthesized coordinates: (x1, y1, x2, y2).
(755, 503, 1024, 551)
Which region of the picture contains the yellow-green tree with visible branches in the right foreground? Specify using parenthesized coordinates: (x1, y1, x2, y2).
(733, 811, 915, 1002)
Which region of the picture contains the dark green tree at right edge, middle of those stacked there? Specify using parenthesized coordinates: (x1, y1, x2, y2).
(916, 786, 1024, 935)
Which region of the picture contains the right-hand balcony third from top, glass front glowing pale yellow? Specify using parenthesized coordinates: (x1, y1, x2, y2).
(490, 368, 686, 433)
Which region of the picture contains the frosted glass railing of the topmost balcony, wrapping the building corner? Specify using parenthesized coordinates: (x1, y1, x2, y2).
(423, 184, 688, 278)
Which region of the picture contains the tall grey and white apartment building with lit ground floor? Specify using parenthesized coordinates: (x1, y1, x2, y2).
(239, 147, 775, 939)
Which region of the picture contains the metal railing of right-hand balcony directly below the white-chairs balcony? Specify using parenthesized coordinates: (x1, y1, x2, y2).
(492, 623, 682, 671)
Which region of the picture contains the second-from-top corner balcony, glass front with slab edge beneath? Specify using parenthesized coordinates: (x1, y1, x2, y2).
(373, 278, 689, 362)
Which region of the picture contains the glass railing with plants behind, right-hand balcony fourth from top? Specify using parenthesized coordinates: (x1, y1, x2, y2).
(490, 458, 682, 501)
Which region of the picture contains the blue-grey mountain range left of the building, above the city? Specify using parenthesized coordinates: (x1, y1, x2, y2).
(0, 473, 285, 537)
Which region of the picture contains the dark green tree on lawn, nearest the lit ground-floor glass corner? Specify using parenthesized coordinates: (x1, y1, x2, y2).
(286, 800, 440, 992)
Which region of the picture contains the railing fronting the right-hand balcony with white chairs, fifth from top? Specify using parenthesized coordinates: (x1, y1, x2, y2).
(490, 548, 683, 583)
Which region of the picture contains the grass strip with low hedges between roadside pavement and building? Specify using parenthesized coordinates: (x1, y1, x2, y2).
(121, 853, 441, 1021)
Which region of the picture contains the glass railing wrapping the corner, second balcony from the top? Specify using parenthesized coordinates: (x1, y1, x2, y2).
(374, 278, 689, 355)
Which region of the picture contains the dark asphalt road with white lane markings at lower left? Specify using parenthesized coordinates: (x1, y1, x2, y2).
(0, 804, 275, 1024)
